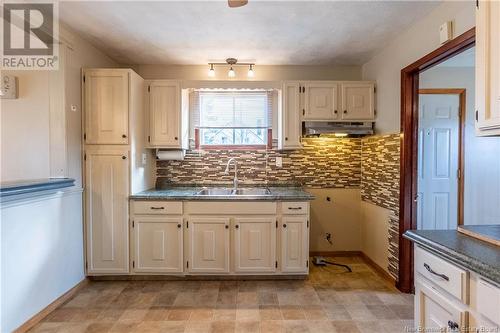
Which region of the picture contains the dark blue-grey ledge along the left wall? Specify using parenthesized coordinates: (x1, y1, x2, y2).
(0, 178, 75, 198)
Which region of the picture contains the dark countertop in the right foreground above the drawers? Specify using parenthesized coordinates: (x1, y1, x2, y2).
(404, 230, 500, 286)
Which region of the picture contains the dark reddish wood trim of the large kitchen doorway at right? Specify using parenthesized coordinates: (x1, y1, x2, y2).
(397, 28, 476, 293)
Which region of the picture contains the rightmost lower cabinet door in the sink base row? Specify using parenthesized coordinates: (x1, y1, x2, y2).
(281, 216, 309, 273)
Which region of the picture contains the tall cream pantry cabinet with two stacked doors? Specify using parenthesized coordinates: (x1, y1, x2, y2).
(82, 69, 154, 275)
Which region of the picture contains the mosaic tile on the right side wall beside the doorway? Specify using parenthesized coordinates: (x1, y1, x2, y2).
(361, 134, 400, 279)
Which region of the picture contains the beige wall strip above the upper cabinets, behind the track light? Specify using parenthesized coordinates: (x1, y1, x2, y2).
(132, 65, 361, 81)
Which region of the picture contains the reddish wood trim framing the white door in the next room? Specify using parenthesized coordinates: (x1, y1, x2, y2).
(418, 88, 467, 225)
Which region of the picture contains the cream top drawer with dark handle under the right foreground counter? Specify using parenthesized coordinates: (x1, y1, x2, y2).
(415, 246, 469, 304)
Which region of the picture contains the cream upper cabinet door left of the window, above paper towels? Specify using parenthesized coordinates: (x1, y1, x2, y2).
(149, 81, 181, 148)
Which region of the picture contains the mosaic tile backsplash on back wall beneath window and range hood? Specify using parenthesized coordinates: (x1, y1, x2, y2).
(156, 137, 361, 188)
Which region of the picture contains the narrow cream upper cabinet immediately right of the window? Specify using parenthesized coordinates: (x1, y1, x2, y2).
(278, 82, 302, 149)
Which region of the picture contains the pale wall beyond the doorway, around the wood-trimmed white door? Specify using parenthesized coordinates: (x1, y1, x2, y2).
(420, 67, 500, 224)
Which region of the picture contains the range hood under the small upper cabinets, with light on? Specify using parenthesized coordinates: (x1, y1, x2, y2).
(302, 121, 374, 137)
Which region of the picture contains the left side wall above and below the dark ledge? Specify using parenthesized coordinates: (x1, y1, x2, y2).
(0, 24, 117, 332)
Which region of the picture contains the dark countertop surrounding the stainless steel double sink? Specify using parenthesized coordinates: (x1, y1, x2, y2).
(130, 186, 314, 201)
